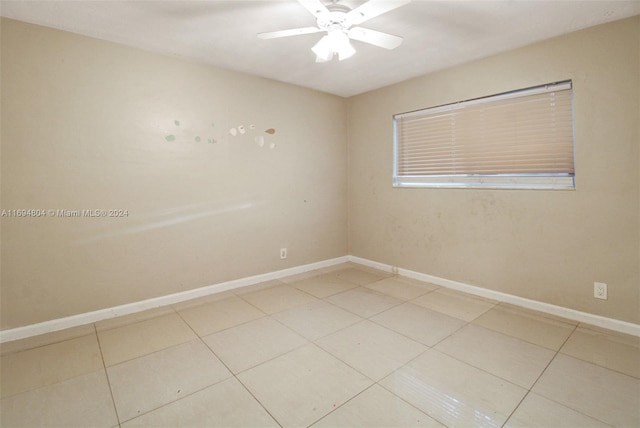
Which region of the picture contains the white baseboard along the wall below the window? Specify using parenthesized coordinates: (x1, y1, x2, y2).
(348, 256, 640, 337)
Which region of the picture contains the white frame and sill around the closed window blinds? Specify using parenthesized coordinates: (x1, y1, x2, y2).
(393, 80, 576, 190)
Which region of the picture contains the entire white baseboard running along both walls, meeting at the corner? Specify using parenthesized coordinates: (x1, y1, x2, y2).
(0, 256, 640, 343)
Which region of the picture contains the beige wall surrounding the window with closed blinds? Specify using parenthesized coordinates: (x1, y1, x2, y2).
(349, 17, 640, 323)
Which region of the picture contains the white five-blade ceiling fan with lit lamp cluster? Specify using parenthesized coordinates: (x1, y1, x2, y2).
(258, 0, 411, 62)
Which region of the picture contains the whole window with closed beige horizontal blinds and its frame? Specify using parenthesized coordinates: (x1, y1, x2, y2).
(393, 81, 575, 189)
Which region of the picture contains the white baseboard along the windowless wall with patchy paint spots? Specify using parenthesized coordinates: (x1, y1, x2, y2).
(0, 256, 349, 343)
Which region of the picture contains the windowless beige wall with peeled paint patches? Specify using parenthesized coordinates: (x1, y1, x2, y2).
(1, 19, 347, 329)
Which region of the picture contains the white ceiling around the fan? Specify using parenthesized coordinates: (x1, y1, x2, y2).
(0, 0, 640, 97)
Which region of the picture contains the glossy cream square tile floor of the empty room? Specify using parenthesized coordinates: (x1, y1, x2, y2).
(0, 265, 640, 428)
